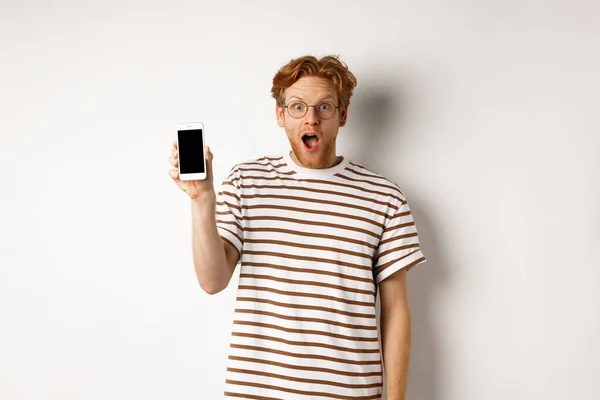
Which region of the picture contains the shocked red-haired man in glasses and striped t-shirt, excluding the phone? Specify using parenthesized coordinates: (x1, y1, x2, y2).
(170, 56, 426, 400)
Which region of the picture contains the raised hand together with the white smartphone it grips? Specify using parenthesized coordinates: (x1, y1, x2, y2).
(169, 122, 214, 200)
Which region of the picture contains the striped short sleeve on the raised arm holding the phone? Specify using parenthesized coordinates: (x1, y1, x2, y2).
(216, 167, 244, 254)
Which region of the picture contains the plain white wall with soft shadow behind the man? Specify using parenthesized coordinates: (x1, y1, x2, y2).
(0, 0, 600, 400)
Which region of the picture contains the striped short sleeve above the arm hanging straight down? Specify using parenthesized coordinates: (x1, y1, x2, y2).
(373, 198, 427, 284)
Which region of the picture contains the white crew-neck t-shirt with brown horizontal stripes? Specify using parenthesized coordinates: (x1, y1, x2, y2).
(217, 153, 426, 400)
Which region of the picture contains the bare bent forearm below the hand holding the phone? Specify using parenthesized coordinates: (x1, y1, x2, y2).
(192, 192, 239, 294)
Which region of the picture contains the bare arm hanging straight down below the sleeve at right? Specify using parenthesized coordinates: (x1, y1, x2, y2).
(379, 269, 411, 400)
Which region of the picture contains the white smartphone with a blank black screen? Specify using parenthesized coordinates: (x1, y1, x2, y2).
(177, 122, 206, 181)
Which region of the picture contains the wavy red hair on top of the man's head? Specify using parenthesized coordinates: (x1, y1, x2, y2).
(271, 56, 356, 107)
